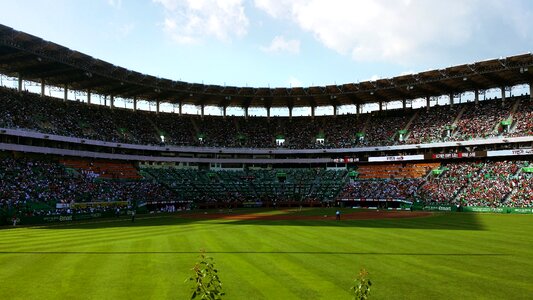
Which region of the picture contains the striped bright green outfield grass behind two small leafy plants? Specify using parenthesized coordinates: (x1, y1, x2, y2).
(0, 210, 533, 299)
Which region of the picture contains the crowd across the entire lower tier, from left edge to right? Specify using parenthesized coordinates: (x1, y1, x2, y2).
(0, 152, 533, 220)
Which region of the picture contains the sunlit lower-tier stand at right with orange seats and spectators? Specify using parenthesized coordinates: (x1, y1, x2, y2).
(340, 160, 533, 207)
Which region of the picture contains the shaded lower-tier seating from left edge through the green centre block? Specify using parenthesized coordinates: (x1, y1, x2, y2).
(0, 156, 347, 215)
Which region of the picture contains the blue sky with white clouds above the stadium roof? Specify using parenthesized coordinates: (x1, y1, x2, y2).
(0, 0, 533, 87)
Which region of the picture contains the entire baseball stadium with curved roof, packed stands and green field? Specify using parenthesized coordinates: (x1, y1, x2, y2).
(0, 7, 533, 299)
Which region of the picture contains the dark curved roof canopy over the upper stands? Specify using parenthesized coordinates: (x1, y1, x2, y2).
(0, 24, 533, 107)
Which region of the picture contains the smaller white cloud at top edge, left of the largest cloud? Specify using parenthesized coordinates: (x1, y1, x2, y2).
(153, 0, 249, 44)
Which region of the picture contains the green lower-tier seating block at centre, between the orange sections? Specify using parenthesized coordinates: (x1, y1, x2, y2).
(141, 168, 347, 202)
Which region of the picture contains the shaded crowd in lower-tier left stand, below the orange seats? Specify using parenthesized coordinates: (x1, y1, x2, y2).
(0, 157, 174, 214)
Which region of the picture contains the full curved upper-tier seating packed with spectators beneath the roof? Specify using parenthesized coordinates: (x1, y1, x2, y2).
(0, 88, 533, 149)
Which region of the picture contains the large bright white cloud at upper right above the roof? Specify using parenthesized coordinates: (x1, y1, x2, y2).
(254, 0, 533, 63)
